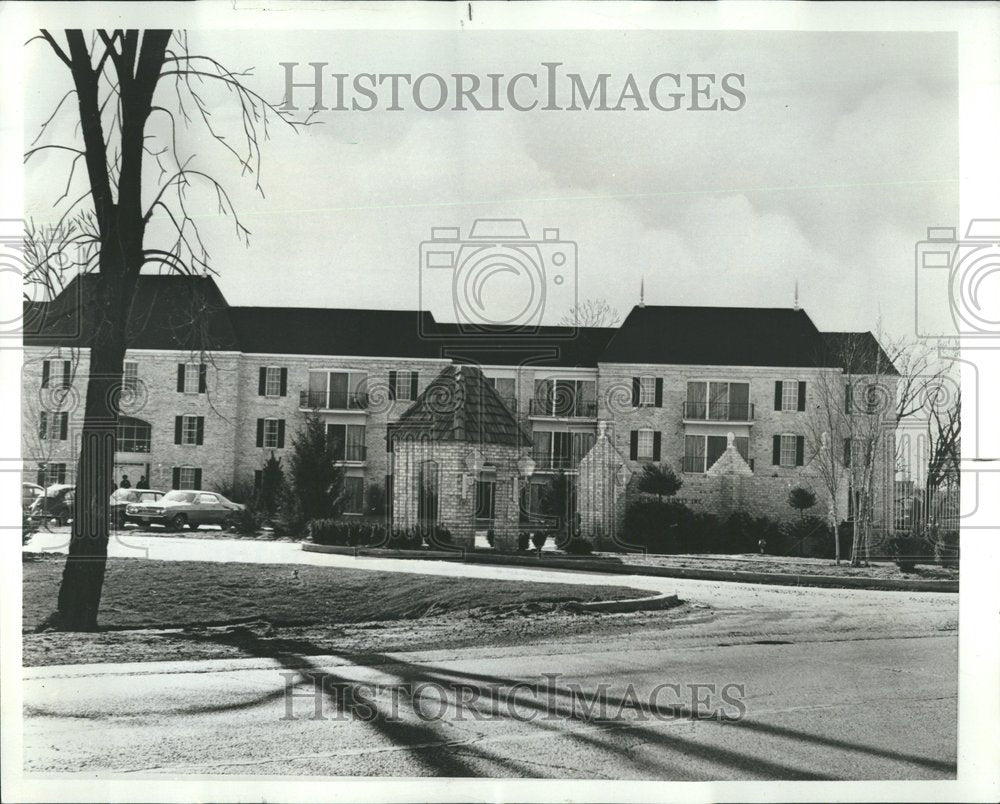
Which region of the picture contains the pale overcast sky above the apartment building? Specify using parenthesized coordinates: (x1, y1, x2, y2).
(26, 31, 958, 333)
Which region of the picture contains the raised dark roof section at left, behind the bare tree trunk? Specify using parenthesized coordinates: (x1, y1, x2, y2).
(24, 274, 240, 351)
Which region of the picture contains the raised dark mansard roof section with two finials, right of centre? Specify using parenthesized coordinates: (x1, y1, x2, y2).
(601, 306, 844, 366)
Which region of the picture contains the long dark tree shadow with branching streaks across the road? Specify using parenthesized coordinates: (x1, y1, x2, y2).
(160, 629, 957, 781)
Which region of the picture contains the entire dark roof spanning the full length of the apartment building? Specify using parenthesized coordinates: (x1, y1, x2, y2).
(24, 275, 896, 373)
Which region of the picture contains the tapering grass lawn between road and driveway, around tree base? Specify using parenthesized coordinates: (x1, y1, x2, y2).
(22, 554, 649, 631)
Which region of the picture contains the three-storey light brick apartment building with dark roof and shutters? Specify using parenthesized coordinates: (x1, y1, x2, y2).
(22, 275, 895, 532)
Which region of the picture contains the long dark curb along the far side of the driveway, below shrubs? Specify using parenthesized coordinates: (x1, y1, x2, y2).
(302, 542, 959, 593)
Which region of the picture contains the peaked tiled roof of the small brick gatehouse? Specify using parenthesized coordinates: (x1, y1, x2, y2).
(389, 365, 531, 447)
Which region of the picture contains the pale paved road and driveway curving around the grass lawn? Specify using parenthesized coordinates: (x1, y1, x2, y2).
(24, 536, 958, 780)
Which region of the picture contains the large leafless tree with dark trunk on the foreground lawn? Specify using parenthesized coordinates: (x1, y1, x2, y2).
(25, 30, 297, 630)
